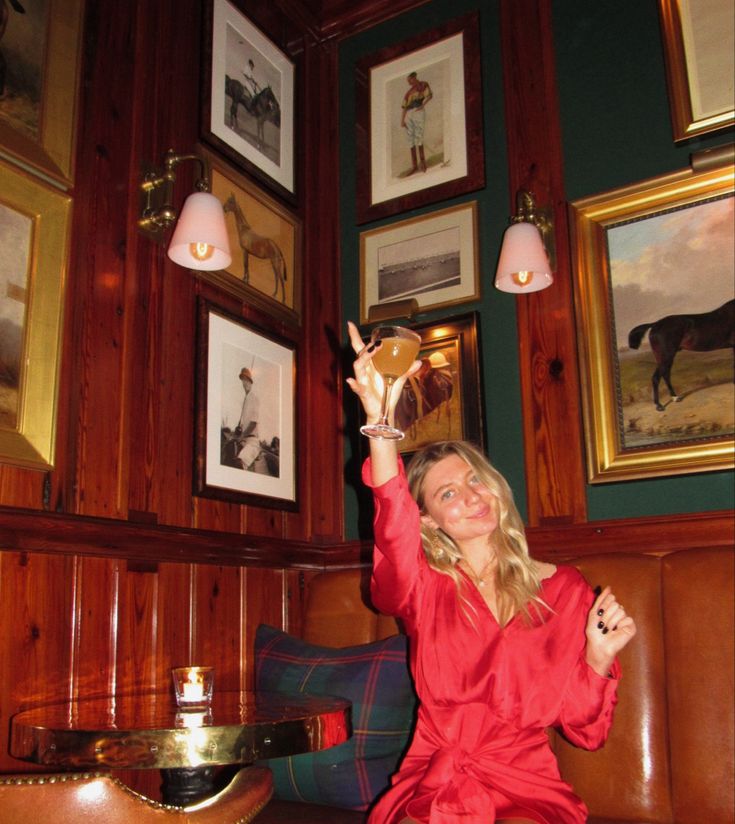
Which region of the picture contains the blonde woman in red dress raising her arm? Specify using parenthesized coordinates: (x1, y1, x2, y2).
(347, 324, 636, 824)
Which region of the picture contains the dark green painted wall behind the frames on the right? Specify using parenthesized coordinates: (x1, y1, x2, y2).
(339, 0, 733, 539)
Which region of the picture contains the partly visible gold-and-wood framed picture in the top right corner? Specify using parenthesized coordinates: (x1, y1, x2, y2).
(659, 0, 735, 142)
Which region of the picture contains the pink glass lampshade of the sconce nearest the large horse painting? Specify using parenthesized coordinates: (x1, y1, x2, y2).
(495, 222, 554, 293)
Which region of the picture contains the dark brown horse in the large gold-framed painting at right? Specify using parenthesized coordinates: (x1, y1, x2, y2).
(628, 300, 735, 412)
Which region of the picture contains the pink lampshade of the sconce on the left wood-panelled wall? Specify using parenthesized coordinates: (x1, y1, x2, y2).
(168, 192, 232, 270)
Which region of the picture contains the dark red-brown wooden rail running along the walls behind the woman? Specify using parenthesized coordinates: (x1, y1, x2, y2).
(0, 507, 735, 571)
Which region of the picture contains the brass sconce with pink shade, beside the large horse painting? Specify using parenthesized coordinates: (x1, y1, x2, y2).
(495, 189, 556, 293)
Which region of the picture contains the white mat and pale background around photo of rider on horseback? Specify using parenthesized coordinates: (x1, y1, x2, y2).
(210, 0, 294, 192)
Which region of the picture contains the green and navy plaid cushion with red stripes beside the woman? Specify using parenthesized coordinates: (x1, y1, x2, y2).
(255, 624, 416, 810)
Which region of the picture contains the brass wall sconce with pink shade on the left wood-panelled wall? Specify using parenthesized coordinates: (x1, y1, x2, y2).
(138, 149, 232, 270)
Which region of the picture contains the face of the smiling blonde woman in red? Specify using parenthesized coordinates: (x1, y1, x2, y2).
(421, 455, 498, 545)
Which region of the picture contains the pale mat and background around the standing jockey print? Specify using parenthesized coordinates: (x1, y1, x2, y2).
(370, 33, 467, 204)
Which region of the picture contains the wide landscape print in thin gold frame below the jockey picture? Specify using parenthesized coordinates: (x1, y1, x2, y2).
(360, 201, 480, 323)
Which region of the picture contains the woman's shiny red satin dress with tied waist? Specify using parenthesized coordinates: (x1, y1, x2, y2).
(363, 461, 620, 824)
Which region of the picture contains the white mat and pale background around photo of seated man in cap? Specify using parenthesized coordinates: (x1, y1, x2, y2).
(206, 312, 296, 501)
